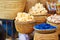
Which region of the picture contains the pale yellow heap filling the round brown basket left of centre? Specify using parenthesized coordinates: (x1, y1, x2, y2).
(16, 12, 34, 22)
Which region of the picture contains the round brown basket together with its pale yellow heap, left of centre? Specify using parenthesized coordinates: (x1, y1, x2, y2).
(15, 12, 35, 34)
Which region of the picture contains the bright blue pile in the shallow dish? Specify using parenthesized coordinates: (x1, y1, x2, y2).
(35, 23, 56, 30)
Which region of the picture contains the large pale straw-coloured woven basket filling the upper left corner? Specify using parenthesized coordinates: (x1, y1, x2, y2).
(0, 0, 26, 19)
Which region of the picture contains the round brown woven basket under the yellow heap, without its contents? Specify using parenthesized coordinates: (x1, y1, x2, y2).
(15, 20, 35, 34)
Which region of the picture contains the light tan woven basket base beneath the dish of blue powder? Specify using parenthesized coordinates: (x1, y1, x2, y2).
(34, 32, 58, 40)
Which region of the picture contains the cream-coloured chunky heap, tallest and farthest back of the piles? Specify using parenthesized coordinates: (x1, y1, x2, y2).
(29, 3, 47, 15)
